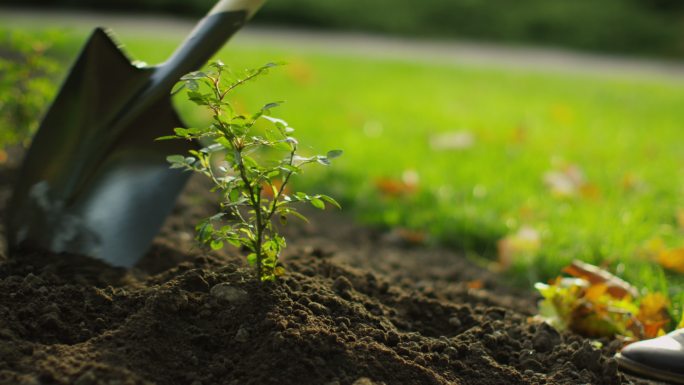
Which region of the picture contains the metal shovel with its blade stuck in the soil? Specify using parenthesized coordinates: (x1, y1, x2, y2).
(6, 0, 265, 267)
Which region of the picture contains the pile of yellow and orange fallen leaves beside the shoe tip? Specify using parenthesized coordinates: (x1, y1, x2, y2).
(536, 261, 684, 342)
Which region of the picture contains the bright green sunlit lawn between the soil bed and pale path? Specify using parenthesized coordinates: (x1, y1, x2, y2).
(5, 25, 684, 320)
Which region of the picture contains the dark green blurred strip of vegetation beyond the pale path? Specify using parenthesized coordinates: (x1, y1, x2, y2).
(3, 0, 684, 57)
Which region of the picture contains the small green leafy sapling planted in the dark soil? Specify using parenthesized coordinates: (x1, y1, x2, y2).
(159, 62, 342, 281)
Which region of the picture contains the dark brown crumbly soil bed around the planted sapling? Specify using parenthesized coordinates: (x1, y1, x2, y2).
(0, 170, 664, 385)
